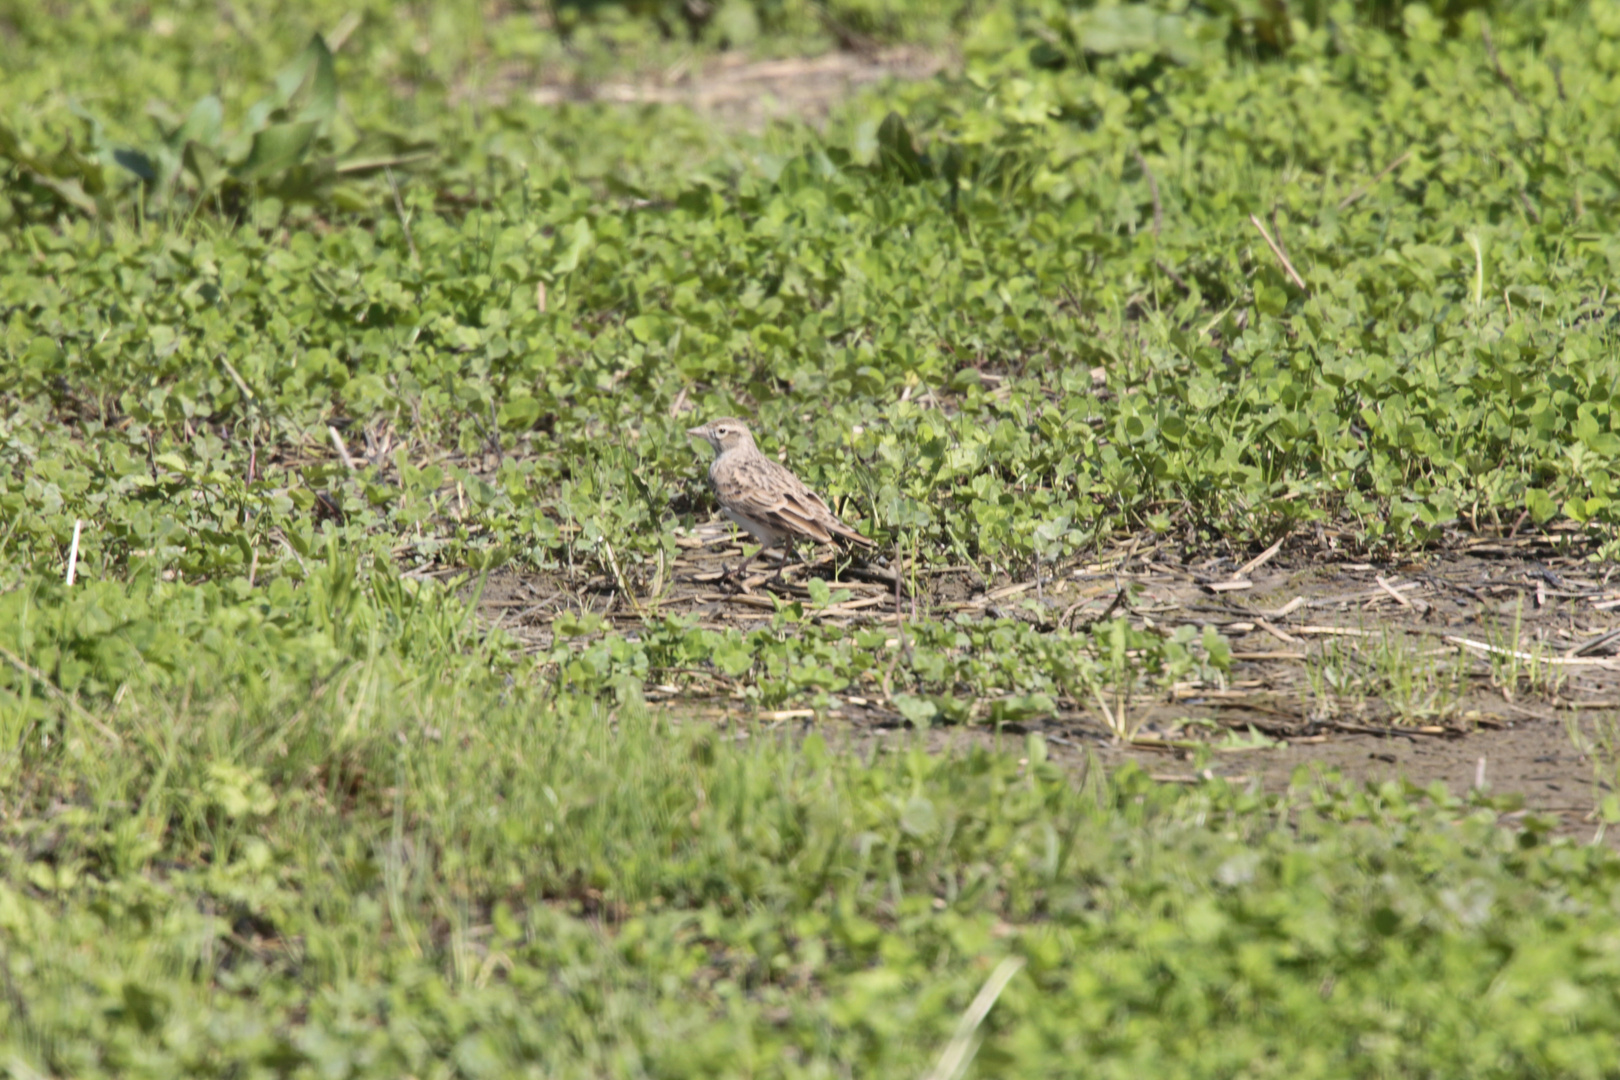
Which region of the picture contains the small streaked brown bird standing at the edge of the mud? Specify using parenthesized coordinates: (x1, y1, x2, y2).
(687, 416, 876, 576)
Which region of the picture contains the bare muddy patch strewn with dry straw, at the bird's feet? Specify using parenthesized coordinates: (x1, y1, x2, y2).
(481, 525, 1620, 834)
